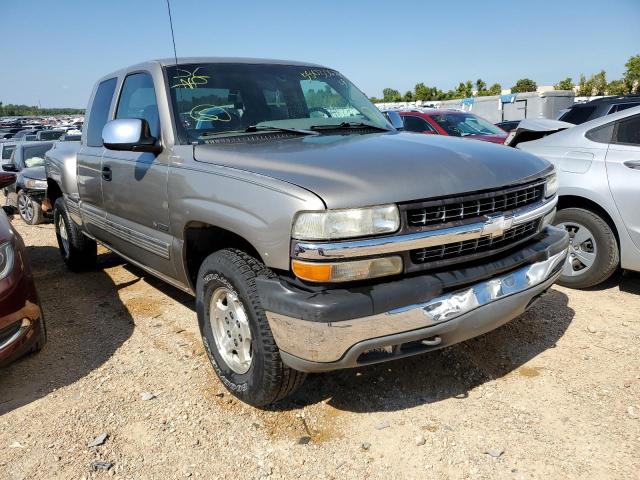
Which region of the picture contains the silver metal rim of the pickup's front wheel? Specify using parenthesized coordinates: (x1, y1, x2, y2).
(209, 287, 253, 375)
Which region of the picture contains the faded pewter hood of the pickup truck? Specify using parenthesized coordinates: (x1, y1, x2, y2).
(194, 132, 551, 208)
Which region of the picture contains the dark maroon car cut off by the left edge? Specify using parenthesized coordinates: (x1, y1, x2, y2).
(0, 172, 47, 366)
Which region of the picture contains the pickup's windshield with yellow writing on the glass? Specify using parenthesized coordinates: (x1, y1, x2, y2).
(166, 63, 393, 143)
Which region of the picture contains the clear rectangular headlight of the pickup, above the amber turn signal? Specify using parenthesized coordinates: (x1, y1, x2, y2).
(292, 205, 400, 240)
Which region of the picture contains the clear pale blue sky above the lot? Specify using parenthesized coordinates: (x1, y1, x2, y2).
(0, 0, 640, 107)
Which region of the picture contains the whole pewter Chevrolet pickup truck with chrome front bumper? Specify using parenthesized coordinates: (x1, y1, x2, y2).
(47, 58, 568, 406)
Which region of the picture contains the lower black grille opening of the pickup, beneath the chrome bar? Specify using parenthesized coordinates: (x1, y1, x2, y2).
(410, 219, 540, 264)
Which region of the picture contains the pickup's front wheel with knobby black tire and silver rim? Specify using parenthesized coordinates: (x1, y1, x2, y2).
(196, 249, 306, 407)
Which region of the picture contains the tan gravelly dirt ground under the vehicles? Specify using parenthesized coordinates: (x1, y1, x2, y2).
(0, 219, 640, 480)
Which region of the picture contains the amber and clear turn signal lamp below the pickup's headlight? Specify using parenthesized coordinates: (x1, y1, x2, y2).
(291, 256, 402, 282)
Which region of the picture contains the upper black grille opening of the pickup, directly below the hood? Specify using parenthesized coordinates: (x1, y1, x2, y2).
(406, 182, 544, 228)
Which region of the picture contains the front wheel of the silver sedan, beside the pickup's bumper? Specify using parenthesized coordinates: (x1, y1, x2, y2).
(554, 208, 620, 289)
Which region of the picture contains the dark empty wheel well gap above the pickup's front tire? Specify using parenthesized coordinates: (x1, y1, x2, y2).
(184, 222, 262, 287)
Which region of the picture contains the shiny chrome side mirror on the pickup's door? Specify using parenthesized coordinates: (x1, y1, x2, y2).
(102, 118, 162, 154)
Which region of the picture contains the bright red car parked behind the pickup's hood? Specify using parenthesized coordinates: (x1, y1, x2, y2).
(399, 109, 507, 143)
